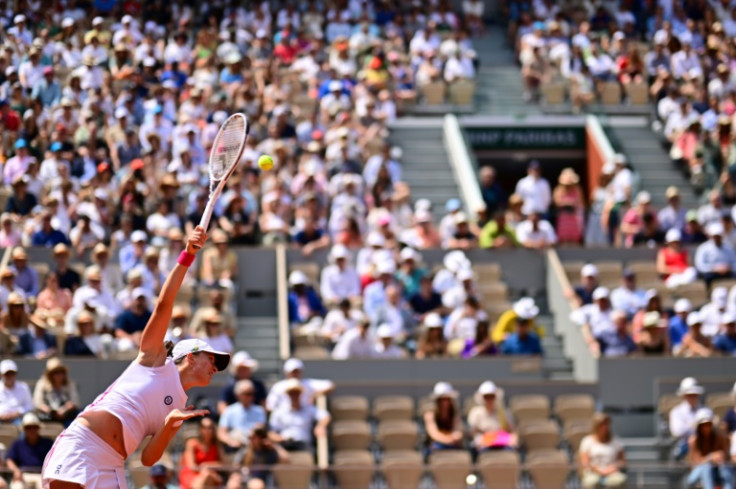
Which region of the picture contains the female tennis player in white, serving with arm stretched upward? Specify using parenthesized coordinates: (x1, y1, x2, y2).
(42, 226, 230, 489)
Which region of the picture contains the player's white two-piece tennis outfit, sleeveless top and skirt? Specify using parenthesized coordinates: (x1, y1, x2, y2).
(41, 358, 187, 489)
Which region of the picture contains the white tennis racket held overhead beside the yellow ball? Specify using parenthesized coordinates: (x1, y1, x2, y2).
(199, 113, 250, 236)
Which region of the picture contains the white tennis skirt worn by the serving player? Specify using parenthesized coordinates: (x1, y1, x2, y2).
(41, 421, 128, 489)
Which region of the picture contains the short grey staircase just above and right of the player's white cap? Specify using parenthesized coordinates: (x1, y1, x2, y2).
(235, 317, 281, 379)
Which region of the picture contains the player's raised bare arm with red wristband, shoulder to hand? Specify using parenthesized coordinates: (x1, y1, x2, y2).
(138, 226, 207, 367)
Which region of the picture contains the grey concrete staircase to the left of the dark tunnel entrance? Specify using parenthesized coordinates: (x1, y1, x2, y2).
(389, 117, 460, 212)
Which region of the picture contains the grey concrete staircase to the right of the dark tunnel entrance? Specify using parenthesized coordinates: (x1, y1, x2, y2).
(604, 117, 698, 209)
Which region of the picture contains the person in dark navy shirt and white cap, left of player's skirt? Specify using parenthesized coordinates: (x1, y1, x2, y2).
(6, 413, 54, 481)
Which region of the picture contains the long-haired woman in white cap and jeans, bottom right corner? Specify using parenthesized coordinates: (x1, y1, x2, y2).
(687, 408, 734, 489)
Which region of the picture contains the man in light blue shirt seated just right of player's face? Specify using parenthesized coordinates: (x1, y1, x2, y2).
(217, 380, 266, 451)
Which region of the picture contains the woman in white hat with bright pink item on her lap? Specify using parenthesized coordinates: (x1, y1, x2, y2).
(468, 380, 518, 452)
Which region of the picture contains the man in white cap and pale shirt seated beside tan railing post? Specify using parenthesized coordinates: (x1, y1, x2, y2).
(269, 379, 330, 450)
